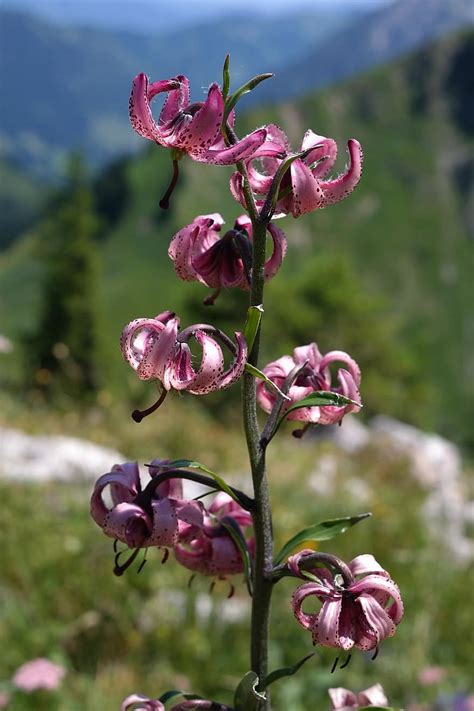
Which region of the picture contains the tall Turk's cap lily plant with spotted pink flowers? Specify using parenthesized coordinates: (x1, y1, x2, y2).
(91, 57, 403, 711)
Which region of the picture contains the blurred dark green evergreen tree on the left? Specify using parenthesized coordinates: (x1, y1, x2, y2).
(27, 156, 99, 399)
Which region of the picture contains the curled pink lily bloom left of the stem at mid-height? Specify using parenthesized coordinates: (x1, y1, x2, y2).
(121, 311, 247, 395)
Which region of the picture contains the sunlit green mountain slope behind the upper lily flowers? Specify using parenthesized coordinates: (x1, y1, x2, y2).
(0, 32, 474, 446)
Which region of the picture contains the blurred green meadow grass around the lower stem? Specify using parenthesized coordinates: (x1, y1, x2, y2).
(0, 403, 474, 711)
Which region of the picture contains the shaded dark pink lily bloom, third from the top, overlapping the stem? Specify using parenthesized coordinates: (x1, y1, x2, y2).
(168, 213, 287, 289)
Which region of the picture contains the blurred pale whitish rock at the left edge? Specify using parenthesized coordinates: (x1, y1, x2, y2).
(0, 427, 127, 481)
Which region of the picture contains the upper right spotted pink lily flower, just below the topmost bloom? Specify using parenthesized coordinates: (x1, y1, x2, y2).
(230, 124, 363, 217)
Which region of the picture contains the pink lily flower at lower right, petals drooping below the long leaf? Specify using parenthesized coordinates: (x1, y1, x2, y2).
(288, 550, 403, 650)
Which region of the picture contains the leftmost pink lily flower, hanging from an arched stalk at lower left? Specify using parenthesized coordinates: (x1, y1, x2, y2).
(91, 460, 203, 548)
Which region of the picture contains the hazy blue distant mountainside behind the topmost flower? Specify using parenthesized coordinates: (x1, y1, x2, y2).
(0, 10, 358, 175)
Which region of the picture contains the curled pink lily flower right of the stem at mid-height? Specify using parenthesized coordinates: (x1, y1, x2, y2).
(257, 343, 361, 425)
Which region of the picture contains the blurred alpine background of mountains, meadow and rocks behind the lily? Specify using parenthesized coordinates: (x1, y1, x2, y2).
(0, 0, 474, 711)
